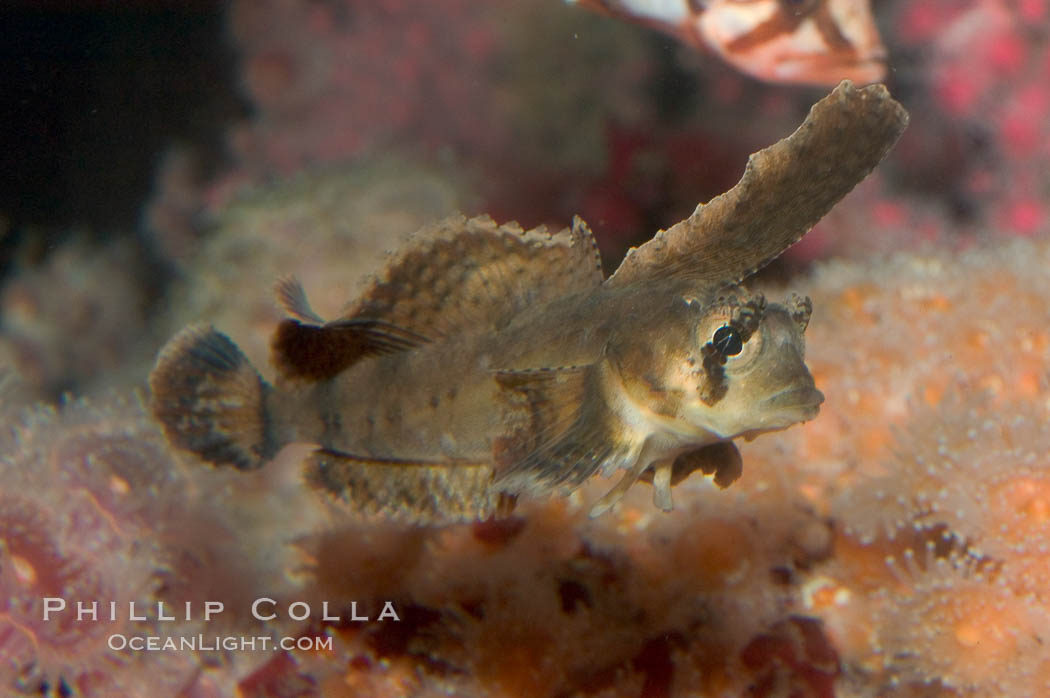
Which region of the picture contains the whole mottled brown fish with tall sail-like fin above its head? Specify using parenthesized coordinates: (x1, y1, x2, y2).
(149, 81, 907, 524)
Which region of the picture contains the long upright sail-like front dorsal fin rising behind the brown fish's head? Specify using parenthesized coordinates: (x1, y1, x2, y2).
(606, 80, 908, 287)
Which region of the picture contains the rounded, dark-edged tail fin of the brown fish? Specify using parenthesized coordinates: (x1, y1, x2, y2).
(149, 325, 280, 470)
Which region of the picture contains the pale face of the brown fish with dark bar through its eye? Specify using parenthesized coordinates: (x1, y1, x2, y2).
(678, 294, 824, 439)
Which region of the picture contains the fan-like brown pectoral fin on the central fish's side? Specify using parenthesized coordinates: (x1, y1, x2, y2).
(495, 364, 637, 492)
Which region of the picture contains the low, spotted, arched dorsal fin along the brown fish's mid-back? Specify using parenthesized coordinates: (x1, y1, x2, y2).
(343, 216, 604, 340)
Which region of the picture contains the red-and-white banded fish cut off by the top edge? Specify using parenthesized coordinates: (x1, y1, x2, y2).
(567, 0, 886, 86)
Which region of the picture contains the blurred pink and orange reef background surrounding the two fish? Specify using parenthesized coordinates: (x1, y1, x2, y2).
(0, 0, 1050, 697)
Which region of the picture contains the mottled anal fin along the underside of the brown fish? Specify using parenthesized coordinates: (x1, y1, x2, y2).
(303, 449, 517, 525)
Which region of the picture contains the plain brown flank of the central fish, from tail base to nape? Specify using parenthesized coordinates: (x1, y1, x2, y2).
(275, 287, 695, 463)
